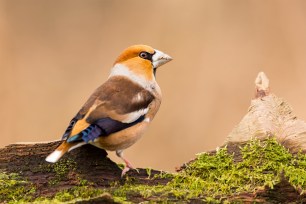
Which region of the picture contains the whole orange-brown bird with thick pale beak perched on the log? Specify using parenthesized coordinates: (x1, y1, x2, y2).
(46, 45, 172, 176)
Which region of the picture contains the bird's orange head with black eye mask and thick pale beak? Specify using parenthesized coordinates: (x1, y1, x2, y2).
(114, 45, 172, 80)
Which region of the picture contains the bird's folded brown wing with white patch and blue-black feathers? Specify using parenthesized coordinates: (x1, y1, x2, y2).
(63, 76, 154, 142)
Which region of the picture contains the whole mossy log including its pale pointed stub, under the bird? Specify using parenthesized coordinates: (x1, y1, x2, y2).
(0, 73, 306, 203)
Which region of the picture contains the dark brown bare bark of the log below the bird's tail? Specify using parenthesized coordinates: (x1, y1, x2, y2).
(0, 141, 169, 201)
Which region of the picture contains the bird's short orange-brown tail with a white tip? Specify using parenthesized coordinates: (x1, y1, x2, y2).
(46, 141, 85, 163)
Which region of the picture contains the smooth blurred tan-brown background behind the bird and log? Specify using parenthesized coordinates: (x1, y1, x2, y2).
(0, 0, 306, 171)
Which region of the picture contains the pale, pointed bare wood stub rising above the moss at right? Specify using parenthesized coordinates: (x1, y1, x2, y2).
(226, 72, 306, 153)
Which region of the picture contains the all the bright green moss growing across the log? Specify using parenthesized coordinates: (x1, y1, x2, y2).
(4, 138, 306, 203)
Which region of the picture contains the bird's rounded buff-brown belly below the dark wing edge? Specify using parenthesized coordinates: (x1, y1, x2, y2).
(91, 122, 148, 151)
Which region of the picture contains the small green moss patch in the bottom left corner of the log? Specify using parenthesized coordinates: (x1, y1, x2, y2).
(0, 172, 35, 203)
